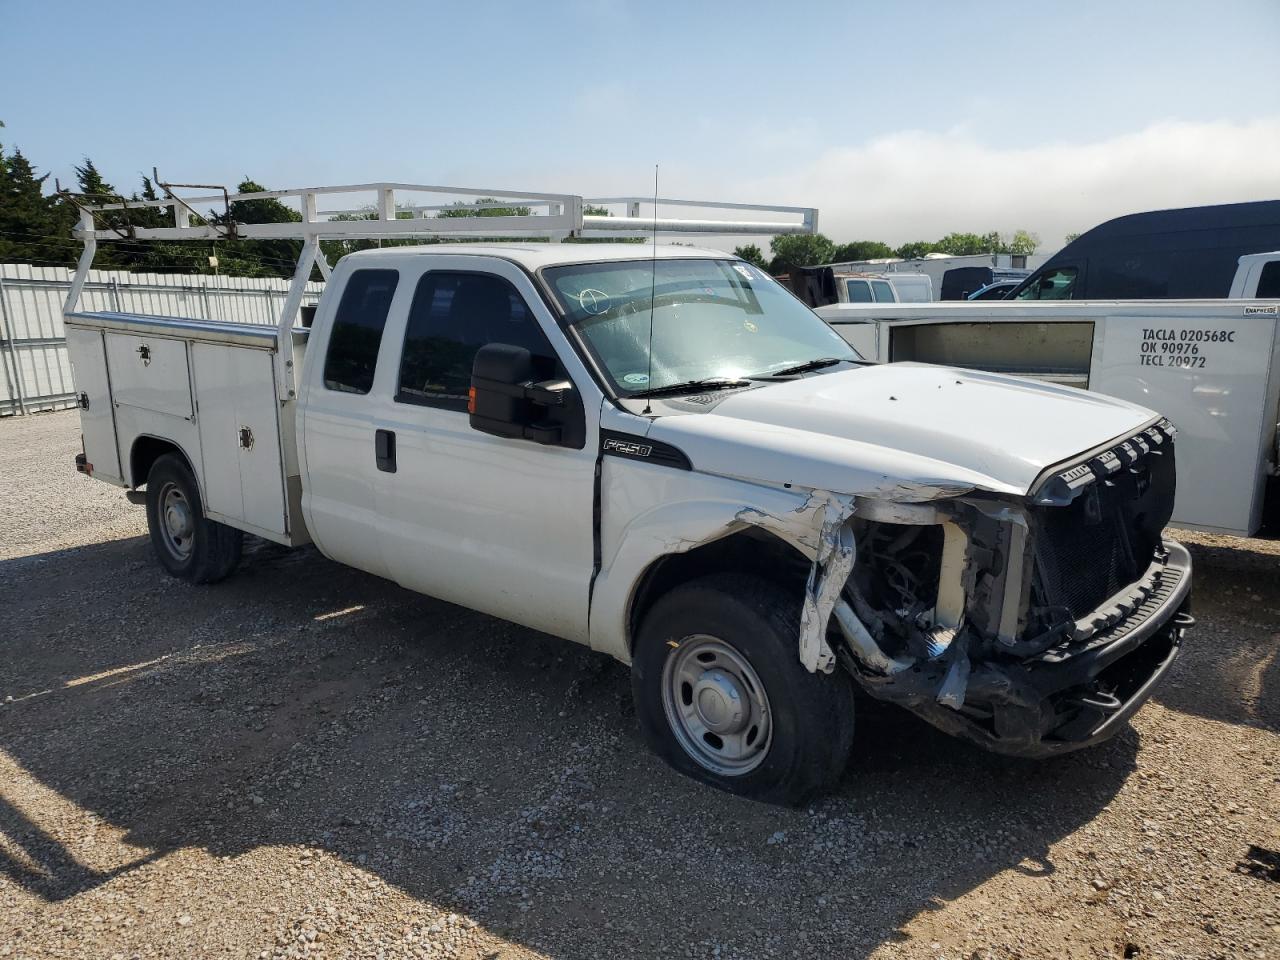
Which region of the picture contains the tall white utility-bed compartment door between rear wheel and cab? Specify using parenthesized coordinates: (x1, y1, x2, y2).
(191, 343, 287, 538)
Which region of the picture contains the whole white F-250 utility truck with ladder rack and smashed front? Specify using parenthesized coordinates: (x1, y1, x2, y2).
(67, 184, 1193, 804)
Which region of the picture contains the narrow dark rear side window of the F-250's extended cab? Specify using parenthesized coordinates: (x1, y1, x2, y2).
(324, 270, 399, 393)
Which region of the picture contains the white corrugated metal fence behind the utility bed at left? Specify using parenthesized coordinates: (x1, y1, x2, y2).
(0, 264, 324, 416)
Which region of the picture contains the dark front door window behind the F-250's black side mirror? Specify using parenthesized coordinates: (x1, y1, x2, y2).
(396, 271, 556, 411)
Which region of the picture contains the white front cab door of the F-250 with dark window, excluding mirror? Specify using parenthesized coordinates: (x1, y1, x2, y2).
(376, 255, 602, 643)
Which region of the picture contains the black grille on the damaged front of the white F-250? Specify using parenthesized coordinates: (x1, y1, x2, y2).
(1033, 439, 1174, 620)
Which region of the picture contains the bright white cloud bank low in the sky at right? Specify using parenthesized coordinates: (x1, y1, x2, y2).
(732, 116, 1280, 250)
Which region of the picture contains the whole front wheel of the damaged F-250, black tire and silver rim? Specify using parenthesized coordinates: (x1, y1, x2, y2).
(631, 573, 854, 805)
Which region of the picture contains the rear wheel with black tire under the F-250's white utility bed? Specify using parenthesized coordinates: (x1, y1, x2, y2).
(147, 453, 244, 584)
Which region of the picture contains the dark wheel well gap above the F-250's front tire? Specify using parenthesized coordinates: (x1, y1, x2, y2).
(627, 527, 812, 650)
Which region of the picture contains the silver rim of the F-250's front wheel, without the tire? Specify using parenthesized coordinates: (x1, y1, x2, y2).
(662, 635, 773, 777)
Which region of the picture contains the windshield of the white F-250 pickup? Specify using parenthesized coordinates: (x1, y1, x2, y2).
(543, 260, 859, 396)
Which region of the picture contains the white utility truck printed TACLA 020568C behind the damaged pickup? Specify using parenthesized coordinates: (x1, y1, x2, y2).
(817, 252, 1280, 536)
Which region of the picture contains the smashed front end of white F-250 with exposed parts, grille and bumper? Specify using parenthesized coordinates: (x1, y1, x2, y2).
(819, 421, 1194, 756)
